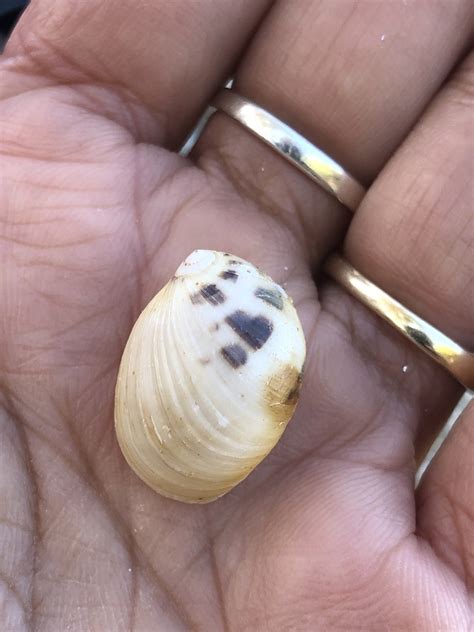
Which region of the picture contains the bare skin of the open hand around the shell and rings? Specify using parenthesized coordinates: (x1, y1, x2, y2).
(0, 0, 474, 632)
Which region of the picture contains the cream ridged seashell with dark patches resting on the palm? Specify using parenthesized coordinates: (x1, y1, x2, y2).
(115, 250, 306, 503)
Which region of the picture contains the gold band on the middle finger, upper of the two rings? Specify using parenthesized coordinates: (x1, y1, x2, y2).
(212, 88, 365, 211)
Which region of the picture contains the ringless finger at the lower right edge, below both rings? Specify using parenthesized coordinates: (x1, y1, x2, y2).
(417, 400, 474, 588)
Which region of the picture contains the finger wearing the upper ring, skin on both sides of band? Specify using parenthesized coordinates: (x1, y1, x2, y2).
(194, 0, 470, 260)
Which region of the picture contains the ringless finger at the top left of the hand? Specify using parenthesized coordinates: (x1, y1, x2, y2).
(4, 0, 269, 147)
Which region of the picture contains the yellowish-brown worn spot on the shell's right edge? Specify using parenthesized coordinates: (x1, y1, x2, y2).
(264, 364, 303, 424)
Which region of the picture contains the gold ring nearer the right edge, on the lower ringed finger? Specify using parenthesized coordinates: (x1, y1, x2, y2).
(325, 255, 474, 390)
